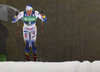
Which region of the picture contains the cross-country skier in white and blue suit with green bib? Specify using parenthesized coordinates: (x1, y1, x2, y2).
(12, 4, 47, 61)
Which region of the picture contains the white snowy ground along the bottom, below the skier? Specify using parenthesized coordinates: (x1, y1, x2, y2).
(0, 61, 100, 72)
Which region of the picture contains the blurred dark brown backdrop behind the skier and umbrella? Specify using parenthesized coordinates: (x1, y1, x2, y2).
(0, 0, 100, 62)
